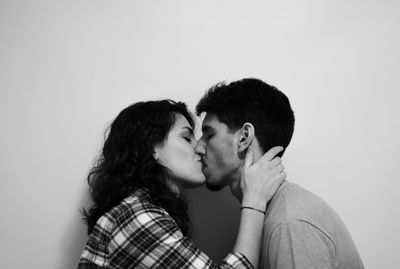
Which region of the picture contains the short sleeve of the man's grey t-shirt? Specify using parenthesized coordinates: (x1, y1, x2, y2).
(264, 220, 336, 269)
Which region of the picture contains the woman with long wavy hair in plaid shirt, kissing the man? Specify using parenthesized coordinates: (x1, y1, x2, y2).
(78, 100, 284, 269)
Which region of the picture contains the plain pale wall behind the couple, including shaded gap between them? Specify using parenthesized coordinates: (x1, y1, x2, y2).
(0, 0, 400, 269)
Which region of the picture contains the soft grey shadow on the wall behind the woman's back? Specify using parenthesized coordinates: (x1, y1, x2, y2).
(57, 188, 89, 269)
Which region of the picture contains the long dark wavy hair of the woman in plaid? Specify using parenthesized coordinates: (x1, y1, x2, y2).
(82, 100, 194, 235)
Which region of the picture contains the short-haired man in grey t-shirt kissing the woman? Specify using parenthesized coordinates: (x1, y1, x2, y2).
(196, 78, 364, 269)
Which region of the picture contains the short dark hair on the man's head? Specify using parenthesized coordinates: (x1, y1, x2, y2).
(196, 78, 294, 154)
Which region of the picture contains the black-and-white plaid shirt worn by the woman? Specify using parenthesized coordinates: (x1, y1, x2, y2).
(78, 189, 253, 269)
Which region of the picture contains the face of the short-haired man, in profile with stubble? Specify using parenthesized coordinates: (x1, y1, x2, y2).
(195, 113, 241, 191)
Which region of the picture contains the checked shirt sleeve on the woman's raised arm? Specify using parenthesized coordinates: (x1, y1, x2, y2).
(108, 206, 253, 269)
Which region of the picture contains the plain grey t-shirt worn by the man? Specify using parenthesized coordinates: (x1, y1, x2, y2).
(260, 181, 364, 269)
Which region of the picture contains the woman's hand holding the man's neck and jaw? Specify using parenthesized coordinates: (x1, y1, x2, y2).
(240, 145, 286, 211)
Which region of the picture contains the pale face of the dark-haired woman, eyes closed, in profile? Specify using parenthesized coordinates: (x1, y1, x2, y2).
(154, 113, 205, 189)
